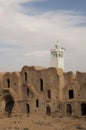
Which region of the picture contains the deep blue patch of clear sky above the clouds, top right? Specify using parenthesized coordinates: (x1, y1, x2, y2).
(23, 0, 86, 14)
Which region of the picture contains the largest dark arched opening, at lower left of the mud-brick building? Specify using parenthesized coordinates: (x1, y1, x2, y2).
(4, 95, 14, 115)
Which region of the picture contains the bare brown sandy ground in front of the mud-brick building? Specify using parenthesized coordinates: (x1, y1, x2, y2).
(0, 114, 86, 130)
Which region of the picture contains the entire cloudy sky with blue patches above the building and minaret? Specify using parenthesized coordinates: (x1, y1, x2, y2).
(0, 0, 86, 72)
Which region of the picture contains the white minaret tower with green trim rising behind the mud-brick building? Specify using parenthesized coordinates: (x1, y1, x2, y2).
(50, 43, 64, 70)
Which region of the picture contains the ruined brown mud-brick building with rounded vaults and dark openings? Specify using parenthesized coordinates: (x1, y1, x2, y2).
(0, 66, 86, 116)
